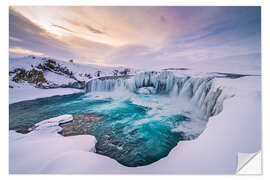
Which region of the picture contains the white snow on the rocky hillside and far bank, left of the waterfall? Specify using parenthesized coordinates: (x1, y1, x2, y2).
(9, 55, 136, 104)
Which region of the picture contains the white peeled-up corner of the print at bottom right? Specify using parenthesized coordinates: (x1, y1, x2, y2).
(236, 152, 262, 175)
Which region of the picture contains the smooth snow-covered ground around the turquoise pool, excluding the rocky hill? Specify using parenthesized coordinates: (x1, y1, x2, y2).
(9, 55, 261, 174)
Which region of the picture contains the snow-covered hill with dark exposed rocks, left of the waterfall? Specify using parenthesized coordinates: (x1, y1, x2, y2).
(9, 55, 136, 89)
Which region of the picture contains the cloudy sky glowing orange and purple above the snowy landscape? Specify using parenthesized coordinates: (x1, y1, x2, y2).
(9, 6, 261, 68)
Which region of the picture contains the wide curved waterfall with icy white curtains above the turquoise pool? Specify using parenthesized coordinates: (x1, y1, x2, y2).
(86, 71, 231, 118)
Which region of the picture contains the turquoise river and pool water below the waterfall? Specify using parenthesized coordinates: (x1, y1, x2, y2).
(9, 93, 205, 167)
